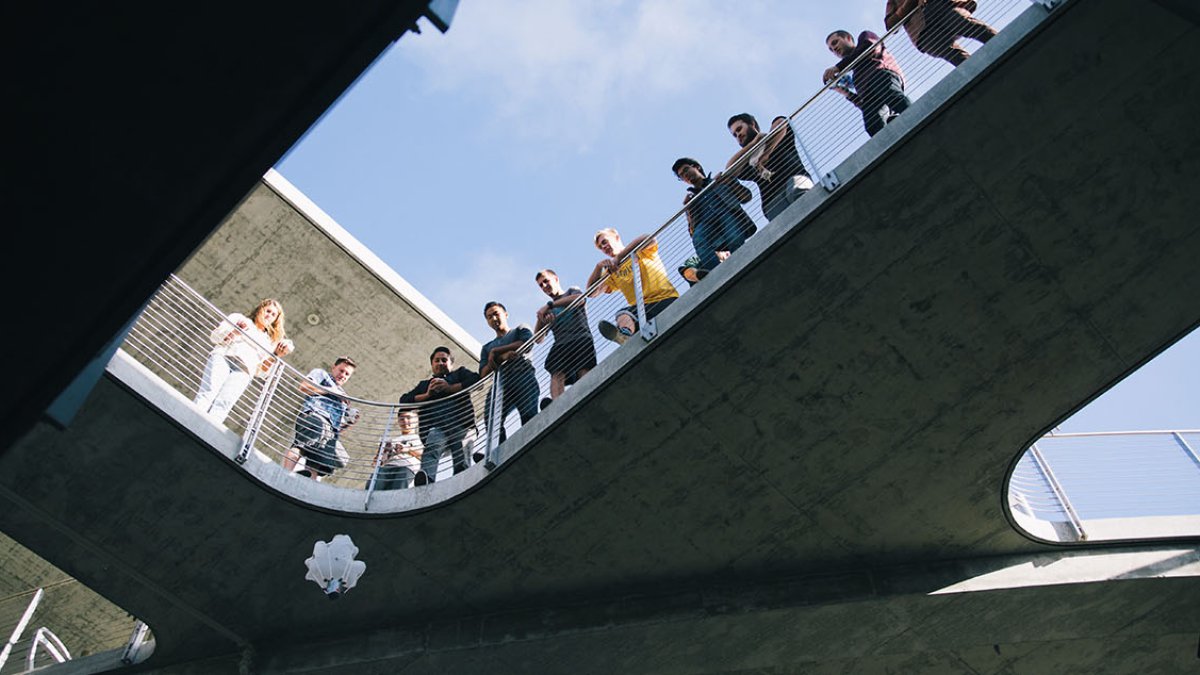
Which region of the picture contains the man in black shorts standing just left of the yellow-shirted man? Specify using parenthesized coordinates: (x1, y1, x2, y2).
(534, 269, 596, 408)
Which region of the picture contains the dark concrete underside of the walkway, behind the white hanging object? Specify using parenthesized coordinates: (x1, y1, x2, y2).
(0, 0, 1200, 673)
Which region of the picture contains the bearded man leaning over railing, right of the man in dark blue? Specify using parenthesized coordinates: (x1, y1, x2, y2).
(725, 113, 812, 221)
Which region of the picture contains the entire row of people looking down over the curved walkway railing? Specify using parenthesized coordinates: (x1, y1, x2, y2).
(194, 0, 996, 490)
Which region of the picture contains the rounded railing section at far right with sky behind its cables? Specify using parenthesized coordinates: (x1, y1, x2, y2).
(1008, 429, 1200, 542)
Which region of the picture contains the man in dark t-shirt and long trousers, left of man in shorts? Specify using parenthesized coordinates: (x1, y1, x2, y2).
(473, 300, 541, 446)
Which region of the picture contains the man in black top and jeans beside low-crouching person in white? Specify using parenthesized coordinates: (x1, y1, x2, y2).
(400, 347, 479, 485)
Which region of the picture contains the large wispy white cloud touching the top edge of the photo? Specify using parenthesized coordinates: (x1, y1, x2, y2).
(407, 0, 823, 150)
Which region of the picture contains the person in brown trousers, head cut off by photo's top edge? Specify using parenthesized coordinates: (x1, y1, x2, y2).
(883, 0, 996, 66)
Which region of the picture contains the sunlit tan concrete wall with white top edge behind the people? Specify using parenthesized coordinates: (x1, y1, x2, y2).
(176, 172, 480, 401)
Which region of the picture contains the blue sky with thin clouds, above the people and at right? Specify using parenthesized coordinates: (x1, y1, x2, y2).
(277, 0, 1200, 431)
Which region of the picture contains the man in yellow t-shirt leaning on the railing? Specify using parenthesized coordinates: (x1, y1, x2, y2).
(588, 227, 679, 345)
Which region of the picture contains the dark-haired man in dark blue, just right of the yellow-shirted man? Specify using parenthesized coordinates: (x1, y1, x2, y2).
(671, 157, 758, 283)
